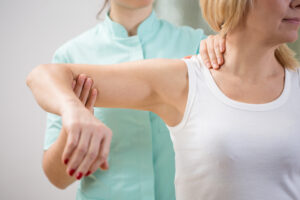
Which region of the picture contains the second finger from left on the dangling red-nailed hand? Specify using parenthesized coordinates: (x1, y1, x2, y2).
(67, 129, 91, 179)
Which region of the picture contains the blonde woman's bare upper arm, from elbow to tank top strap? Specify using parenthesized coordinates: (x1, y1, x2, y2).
(59, 59, 188, 123)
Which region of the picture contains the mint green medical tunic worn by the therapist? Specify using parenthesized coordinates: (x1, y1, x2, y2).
(44, 12, 205, 200)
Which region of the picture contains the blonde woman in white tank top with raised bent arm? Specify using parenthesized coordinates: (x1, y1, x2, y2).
(27, 0, 300, 200)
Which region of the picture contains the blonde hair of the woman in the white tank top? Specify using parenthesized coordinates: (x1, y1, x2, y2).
(200, 0, 299, 70)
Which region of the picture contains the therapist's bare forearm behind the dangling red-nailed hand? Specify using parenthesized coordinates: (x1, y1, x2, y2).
(43, 129, 76, 189)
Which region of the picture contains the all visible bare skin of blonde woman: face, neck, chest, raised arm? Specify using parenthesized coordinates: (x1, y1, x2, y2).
(27, 0, 300, 186)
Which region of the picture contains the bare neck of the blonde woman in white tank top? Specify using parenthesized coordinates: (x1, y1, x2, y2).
(222, 30, 283, 81)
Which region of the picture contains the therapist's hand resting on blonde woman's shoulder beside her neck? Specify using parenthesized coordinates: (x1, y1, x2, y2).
(199, 34, 226, 69)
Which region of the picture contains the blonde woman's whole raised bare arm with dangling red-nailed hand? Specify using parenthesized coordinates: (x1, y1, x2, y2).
(27, 59, 188, 179)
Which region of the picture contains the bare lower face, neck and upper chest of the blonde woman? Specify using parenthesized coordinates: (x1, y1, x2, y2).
(211, 0, 300, 104)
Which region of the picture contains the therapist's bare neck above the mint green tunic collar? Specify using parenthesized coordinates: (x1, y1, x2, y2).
(110, 1, 152, 36)
